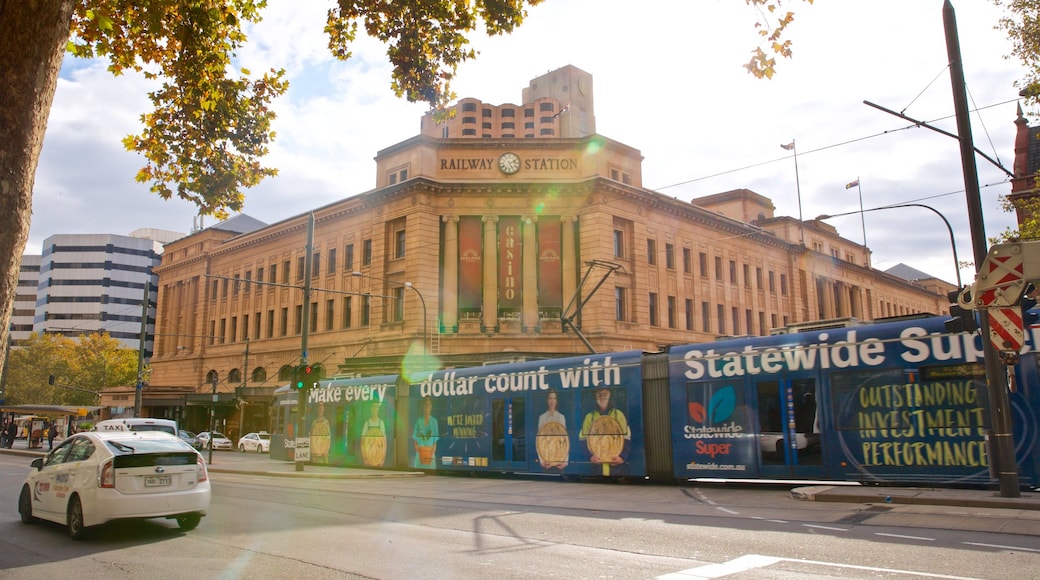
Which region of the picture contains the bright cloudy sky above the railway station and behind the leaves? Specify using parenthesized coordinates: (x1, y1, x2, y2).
(26, 0, 1037, 283)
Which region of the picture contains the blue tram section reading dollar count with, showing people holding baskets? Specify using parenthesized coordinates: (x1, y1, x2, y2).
(408, 351, 646, 476)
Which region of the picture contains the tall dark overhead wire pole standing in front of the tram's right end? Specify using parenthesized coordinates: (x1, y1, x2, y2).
(942, 0, 1021, 498)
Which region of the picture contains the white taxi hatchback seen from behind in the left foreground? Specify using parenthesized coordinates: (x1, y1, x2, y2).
(18, 431, 210, 539)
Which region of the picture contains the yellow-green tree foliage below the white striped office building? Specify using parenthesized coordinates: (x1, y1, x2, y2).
(5, 333, 138, 405)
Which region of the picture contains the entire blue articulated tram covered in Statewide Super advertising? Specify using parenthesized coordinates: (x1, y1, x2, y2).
(271, 317, 1040, 486)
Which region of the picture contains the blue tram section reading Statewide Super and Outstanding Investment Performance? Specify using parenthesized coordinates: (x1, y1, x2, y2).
(670, 317, 1037, 485)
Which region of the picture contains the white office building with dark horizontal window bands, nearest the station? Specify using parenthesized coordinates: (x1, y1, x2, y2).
(31, 229, 184, 357)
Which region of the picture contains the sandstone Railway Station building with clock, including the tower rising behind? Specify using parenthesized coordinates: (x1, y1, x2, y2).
(142, 65, 953, 432)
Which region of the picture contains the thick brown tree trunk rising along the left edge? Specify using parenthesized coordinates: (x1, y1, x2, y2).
(0, 0, 73, 368)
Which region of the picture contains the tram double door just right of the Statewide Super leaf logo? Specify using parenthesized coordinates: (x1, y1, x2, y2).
(755, 375, 823, 477)
